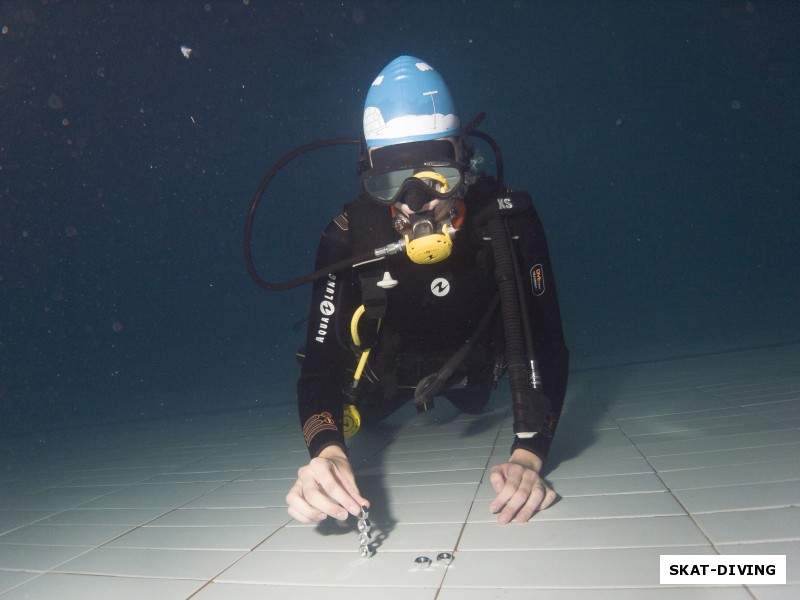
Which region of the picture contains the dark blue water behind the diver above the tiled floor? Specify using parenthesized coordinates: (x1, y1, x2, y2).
(0, 0, 800, 432)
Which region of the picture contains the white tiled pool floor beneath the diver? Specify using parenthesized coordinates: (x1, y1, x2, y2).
(0, 346, 800, 600)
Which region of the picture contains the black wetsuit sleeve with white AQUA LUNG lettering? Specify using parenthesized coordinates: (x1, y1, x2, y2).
(297, 215, 359, 458)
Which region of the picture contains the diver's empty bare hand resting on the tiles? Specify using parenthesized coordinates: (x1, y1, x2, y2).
(489, 448, 556, 525)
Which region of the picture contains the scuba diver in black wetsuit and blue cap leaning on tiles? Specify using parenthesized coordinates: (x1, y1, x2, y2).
(253, 56, 568, 524)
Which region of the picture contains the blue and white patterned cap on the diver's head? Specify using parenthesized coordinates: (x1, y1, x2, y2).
(364, 56, 461, 148)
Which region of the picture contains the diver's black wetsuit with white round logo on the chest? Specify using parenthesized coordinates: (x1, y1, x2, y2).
(297, 177, 568, 459)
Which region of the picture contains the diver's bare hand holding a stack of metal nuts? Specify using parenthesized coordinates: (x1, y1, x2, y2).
(286, 445, 369, 523)
